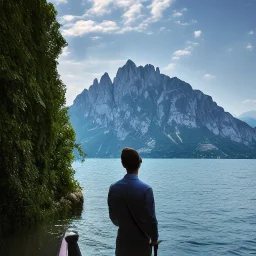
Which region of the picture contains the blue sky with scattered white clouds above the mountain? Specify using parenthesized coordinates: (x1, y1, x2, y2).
(49, 0, 256, 116)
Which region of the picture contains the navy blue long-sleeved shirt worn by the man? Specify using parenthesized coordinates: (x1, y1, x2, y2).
(108, 174, 158, 243)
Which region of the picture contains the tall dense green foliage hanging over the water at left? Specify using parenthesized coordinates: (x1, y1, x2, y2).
(0, 0, 84, 234)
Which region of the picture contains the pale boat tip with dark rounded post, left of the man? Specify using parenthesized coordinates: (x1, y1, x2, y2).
(58, 231, 82, 256)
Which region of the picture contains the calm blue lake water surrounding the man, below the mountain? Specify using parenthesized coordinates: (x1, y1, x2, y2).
(0, 159, 256, 256)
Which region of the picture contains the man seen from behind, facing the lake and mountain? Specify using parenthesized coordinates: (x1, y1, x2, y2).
(108, 148, 158, 256)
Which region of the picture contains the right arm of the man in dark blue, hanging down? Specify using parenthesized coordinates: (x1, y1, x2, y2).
(145, 188, 158, 243)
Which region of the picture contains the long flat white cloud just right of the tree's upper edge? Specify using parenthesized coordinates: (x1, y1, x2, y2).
(63, 20, 119, 36)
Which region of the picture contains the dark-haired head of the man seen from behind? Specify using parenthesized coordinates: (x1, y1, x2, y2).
(121, 148, 142, 173)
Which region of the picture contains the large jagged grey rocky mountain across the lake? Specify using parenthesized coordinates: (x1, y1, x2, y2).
(69, 60, 256, 158)
